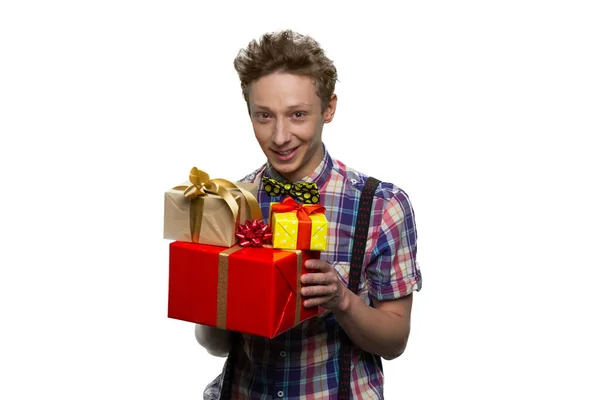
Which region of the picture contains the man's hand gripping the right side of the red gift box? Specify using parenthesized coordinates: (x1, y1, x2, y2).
(300, 260, 350, 311)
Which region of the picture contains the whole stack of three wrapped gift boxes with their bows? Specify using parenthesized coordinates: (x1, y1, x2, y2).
(164, 167, 328, 338)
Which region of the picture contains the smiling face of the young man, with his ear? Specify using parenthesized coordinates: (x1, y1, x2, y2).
(248, 73, 336, 182)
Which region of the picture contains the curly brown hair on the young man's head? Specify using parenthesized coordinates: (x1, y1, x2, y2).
(233, 29, 337, 111)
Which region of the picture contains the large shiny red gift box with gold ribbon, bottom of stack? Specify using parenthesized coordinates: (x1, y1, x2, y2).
(168, 241, 319, 338)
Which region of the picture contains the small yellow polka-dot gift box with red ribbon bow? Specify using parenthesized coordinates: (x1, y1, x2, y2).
(269, 197, 329, 251)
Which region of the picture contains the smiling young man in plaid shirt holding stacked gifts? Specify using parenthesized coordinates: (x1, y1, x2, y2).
(196, 31, 421, 399)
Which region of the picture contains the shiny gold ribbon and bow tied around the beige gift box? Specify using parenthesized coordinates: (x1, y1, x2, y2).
(173, 167, 262, 243)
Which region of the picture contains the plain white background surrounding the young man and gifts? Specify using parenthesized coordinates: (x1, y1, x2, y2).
(0, 0, 600, 399)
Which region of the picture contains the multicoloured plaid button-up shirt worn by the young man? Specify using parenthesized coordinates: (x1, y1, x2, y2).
(204, 146, 421, 400)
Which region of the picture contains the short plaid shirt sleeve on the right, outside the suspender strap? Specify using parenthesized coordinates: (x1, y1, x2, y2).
(366, 188, 422, 300)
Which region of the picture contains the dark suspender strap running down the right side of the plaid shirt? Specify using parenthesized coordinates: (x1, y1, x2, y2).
(338, 177, 380, 400)
